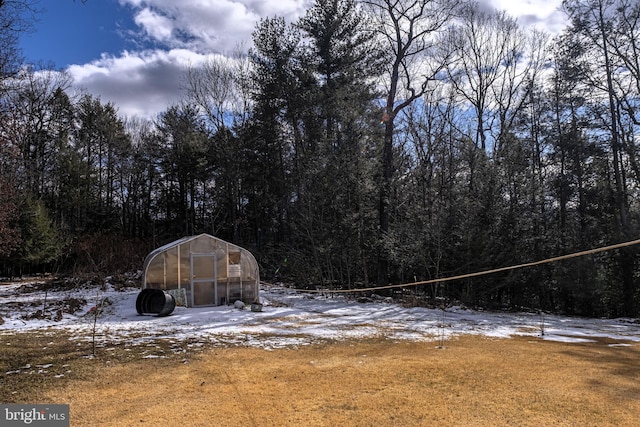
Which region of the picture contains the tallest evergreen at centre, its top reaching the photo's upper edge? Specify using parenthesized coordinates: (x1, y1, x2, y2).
(295, 0, 382, 285)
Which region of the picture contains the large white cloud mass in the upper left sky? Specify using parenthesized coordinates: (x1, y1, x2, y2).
(68, 0, 311, 118)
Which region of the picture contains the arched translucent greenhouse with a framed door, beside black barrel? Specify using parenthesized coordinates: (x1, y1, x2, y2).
(143, 234, 260, 307)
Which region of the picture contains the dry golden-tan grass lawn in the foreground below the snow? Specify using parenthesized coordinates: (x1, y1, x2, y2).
(44, 337, 640, 427)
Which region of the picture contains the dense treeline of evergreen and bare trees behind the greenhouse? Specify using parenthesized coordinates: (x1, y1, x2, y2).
(0, 0, 640, 316)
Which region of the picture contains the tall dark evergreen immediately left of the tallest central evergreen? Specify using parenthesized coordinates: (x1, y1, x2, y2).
(245, 17, 304, 274)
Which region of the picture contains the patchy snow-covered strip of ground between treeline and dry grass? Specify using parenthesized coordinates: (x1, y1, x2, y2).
(0, 283, 640, 349)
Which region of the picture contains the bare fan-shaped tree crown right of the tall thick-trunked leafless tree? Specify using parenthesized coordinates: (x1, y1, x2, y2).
(448, 3, 544, 151)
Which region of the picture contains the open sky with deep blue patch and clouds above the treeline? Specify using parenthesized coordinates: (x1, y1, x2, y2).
(16, 0, 564, 118)
